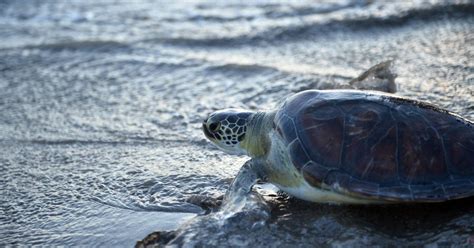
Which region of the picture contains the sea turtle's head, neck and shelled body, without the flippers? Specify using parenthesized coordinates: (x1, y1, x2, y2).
(202, 90, 474, 204)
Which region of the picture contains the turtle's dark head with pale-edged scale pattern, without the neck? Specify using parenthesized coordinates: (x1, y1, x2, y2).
(202, 109, 254, 155)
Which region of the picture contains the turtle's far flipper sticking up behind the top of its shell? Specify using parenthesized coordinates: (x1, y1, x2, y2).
(349, 60, 397, 93)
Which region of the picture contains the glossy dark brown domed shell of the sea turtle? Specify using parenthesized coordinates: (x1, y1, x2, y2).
(274, 90, 474, 202)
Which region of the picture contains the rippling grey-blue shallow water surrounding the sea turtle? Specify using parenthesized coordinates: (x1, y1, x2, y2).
(0, 0, 474, 246)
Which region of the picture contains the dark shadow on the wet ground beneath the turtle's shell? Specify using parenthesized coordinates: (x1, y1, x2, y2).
(272, 197, 474, 238)
